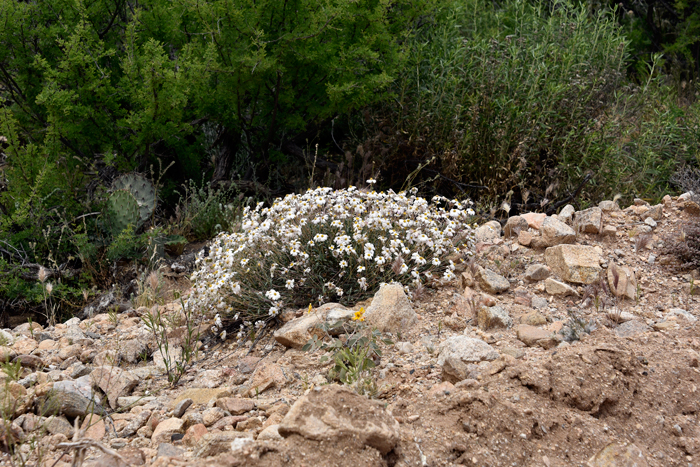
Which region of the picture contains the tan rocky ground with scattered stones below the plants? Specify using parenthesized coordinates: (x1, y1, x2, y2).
(0, 195, 700, 467)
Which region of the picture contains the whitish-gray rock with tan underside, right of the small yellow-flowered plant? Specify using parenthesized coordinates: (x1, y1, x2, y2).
(437, 336, 498, 382)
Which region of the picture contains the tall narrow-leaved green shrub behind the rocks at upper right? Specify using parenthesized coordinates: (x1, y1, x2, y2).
(362, 0, 698, 209)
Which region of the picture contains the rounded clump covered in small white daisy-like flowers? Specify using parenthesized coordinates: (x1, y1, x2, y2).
(188, 187, 474, 338)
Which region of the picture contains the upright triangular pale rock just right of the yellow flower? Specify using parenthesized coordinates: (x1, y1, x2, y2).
(365, 284, 418, 333)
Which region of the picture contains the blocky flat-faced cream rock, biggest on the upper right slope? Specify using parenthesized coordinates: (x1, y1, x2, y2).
(544, 245, 601, 284)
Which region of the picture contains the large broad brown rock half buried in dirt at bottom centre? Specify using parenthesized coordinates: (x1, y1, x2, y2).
(278, 384, 401, 454)
